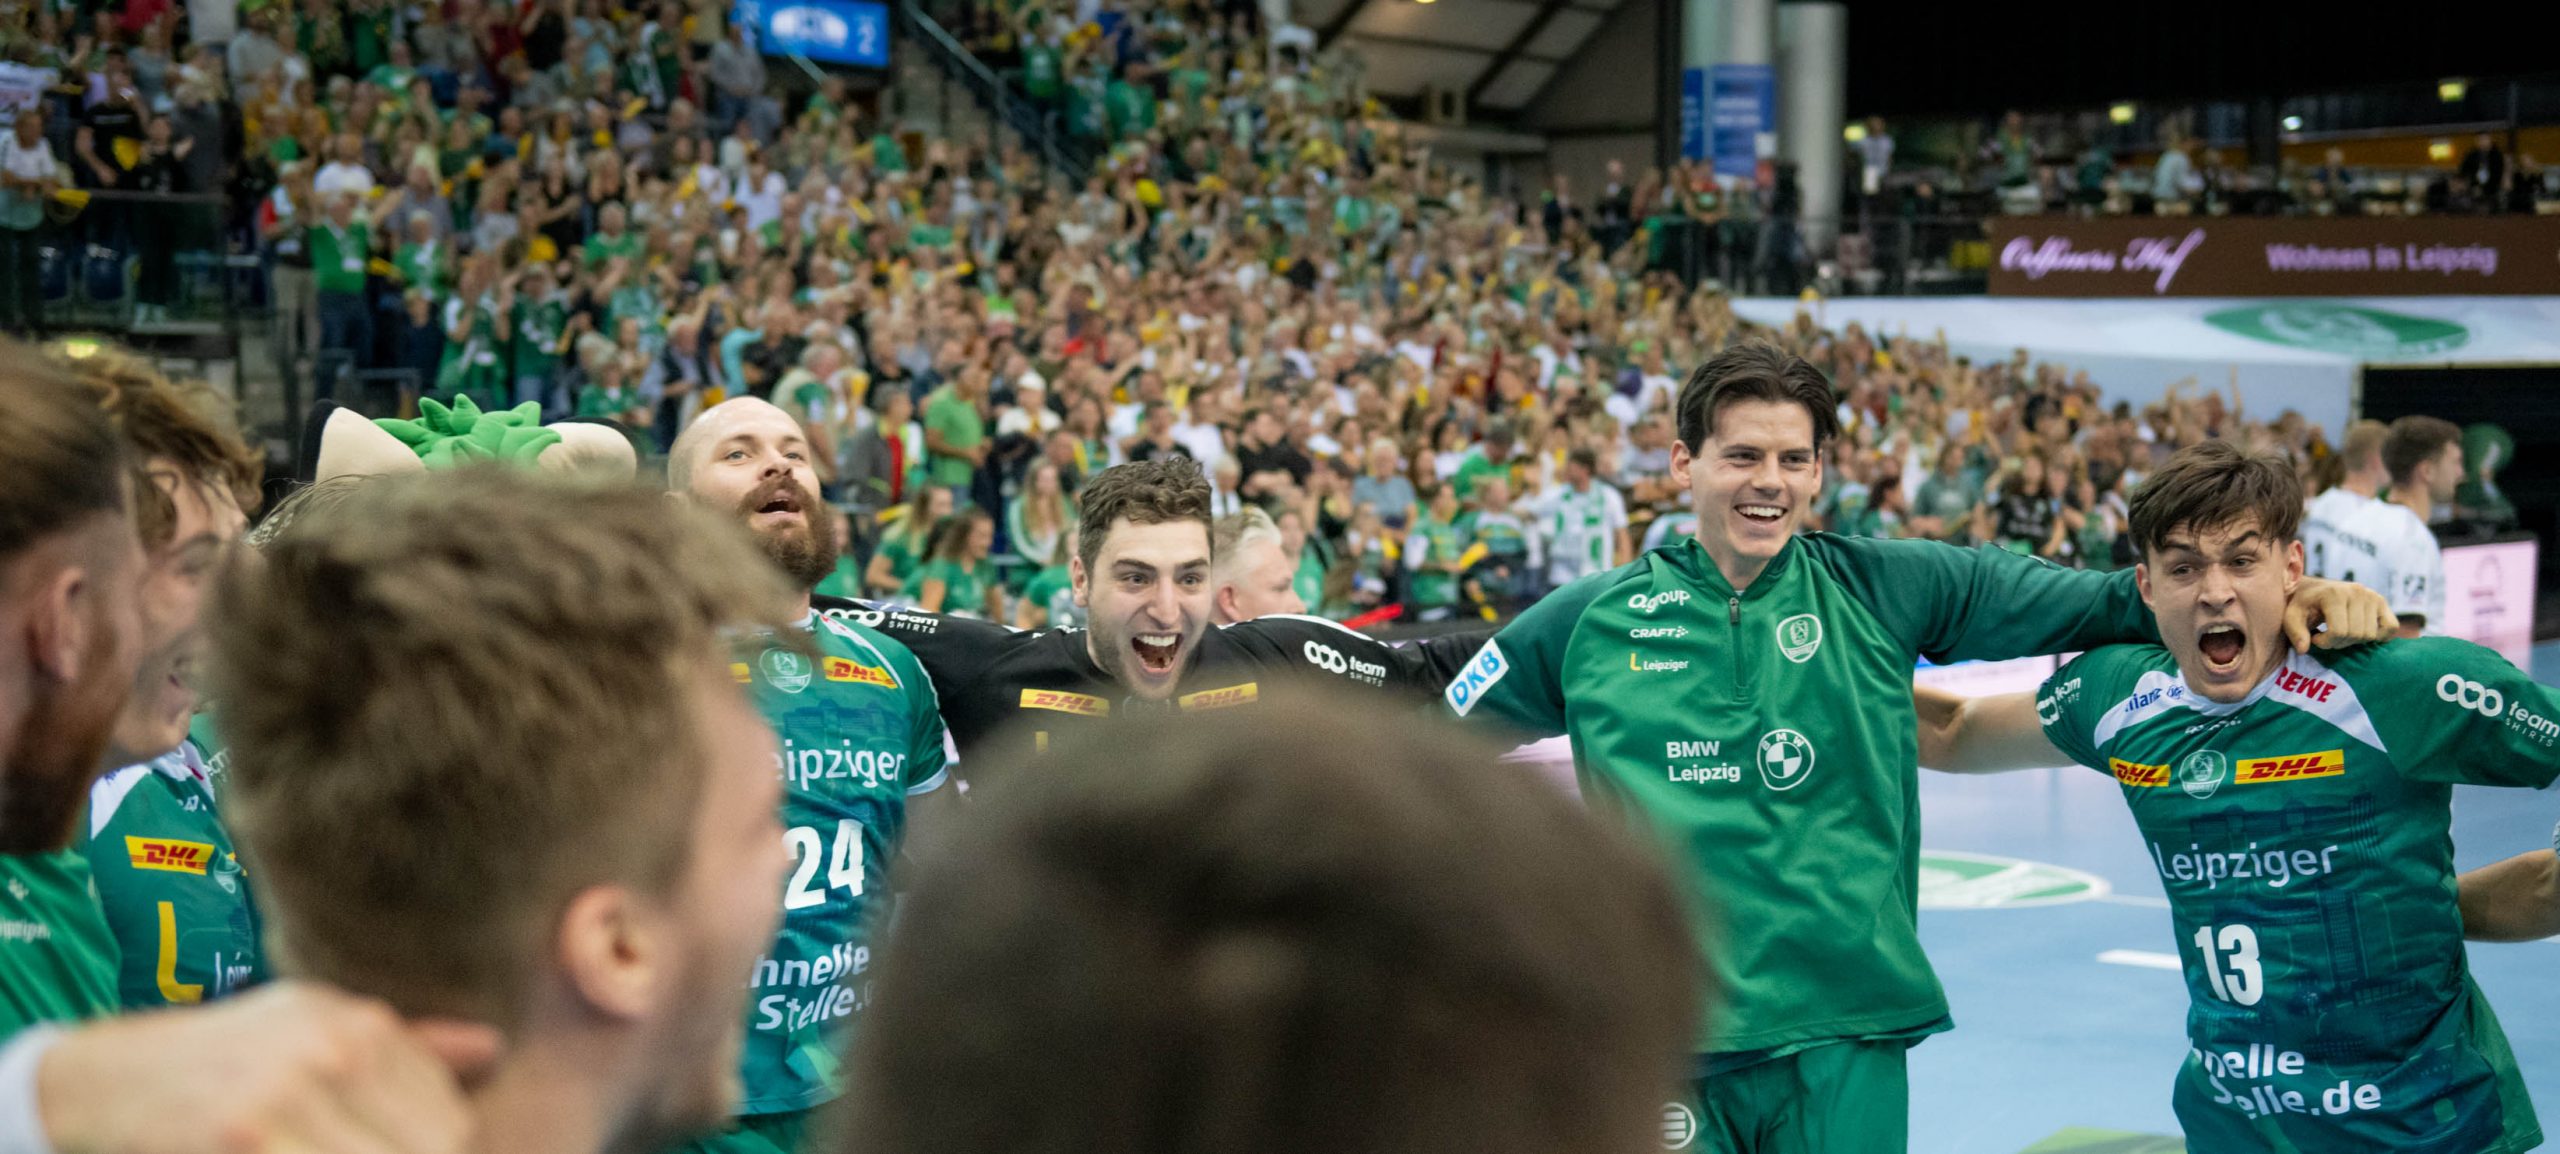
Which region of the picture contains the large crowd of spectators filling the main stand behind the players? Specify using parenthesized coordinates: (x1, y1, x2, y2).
(8, 0, 2385, 627)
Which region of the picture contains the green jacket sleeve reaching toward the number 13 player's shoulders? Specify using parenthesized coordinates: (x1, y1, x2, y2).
(1797, 532, 2161, 665)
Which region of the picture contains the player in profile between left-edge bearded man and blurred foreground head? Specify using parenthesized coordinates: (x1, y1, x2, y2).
(67, 353, 264, 1008)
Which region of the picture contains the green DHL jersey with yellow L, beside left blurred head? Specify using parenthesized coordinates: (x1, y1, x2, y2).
(79, 745, 266, 1008)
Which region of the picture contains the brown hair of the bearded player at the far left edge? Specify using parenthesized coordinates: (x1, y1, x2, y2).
(0, 353, 125, 563)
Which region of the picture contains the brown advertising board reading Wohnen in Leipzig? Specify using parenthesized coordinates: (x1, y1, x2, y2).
(1992, 215, 2560, 297)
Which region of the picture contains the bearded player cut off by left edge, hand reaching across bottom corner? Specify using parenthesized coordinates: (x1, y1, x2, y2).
(0, 355, 497, 1154)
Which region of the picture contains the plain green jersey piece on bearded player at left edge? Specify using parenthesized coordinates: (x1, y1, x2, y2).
(0, 850, 120, 1041)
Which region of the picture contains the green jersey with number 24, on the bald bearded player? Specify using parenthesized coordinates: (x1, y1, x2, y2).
(732, 617, 955, 1113)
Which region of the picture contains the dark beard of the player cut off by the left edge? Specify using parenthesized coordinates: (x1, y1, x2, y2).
(0, 663, 133, 855)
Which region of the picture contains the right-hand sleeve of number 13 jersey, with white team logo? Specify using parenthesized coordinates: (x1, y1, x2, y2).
(2330, 637, 2560, 788)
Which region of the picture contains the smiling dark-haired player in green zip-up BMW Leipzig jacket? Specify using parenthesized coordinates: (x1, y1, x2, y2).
(1446, 343, 2383, 1154)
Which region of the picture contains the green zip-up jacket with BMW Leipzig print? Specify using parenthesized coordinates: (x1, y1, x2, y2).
(1446, 532, 2158, 1057)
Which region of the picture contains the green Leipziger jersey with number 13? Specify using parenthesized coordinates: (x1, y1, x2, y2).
(2038, 637, 2560, 1154)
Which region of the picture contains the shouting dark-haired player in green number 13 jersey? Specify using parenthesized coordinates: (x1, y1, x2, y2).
(1920, 443, 2560, 1154)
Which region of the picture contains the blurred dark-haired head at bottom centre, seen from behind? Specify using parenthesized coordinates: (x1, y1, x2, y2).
(840, 701, 1695, 1154)
